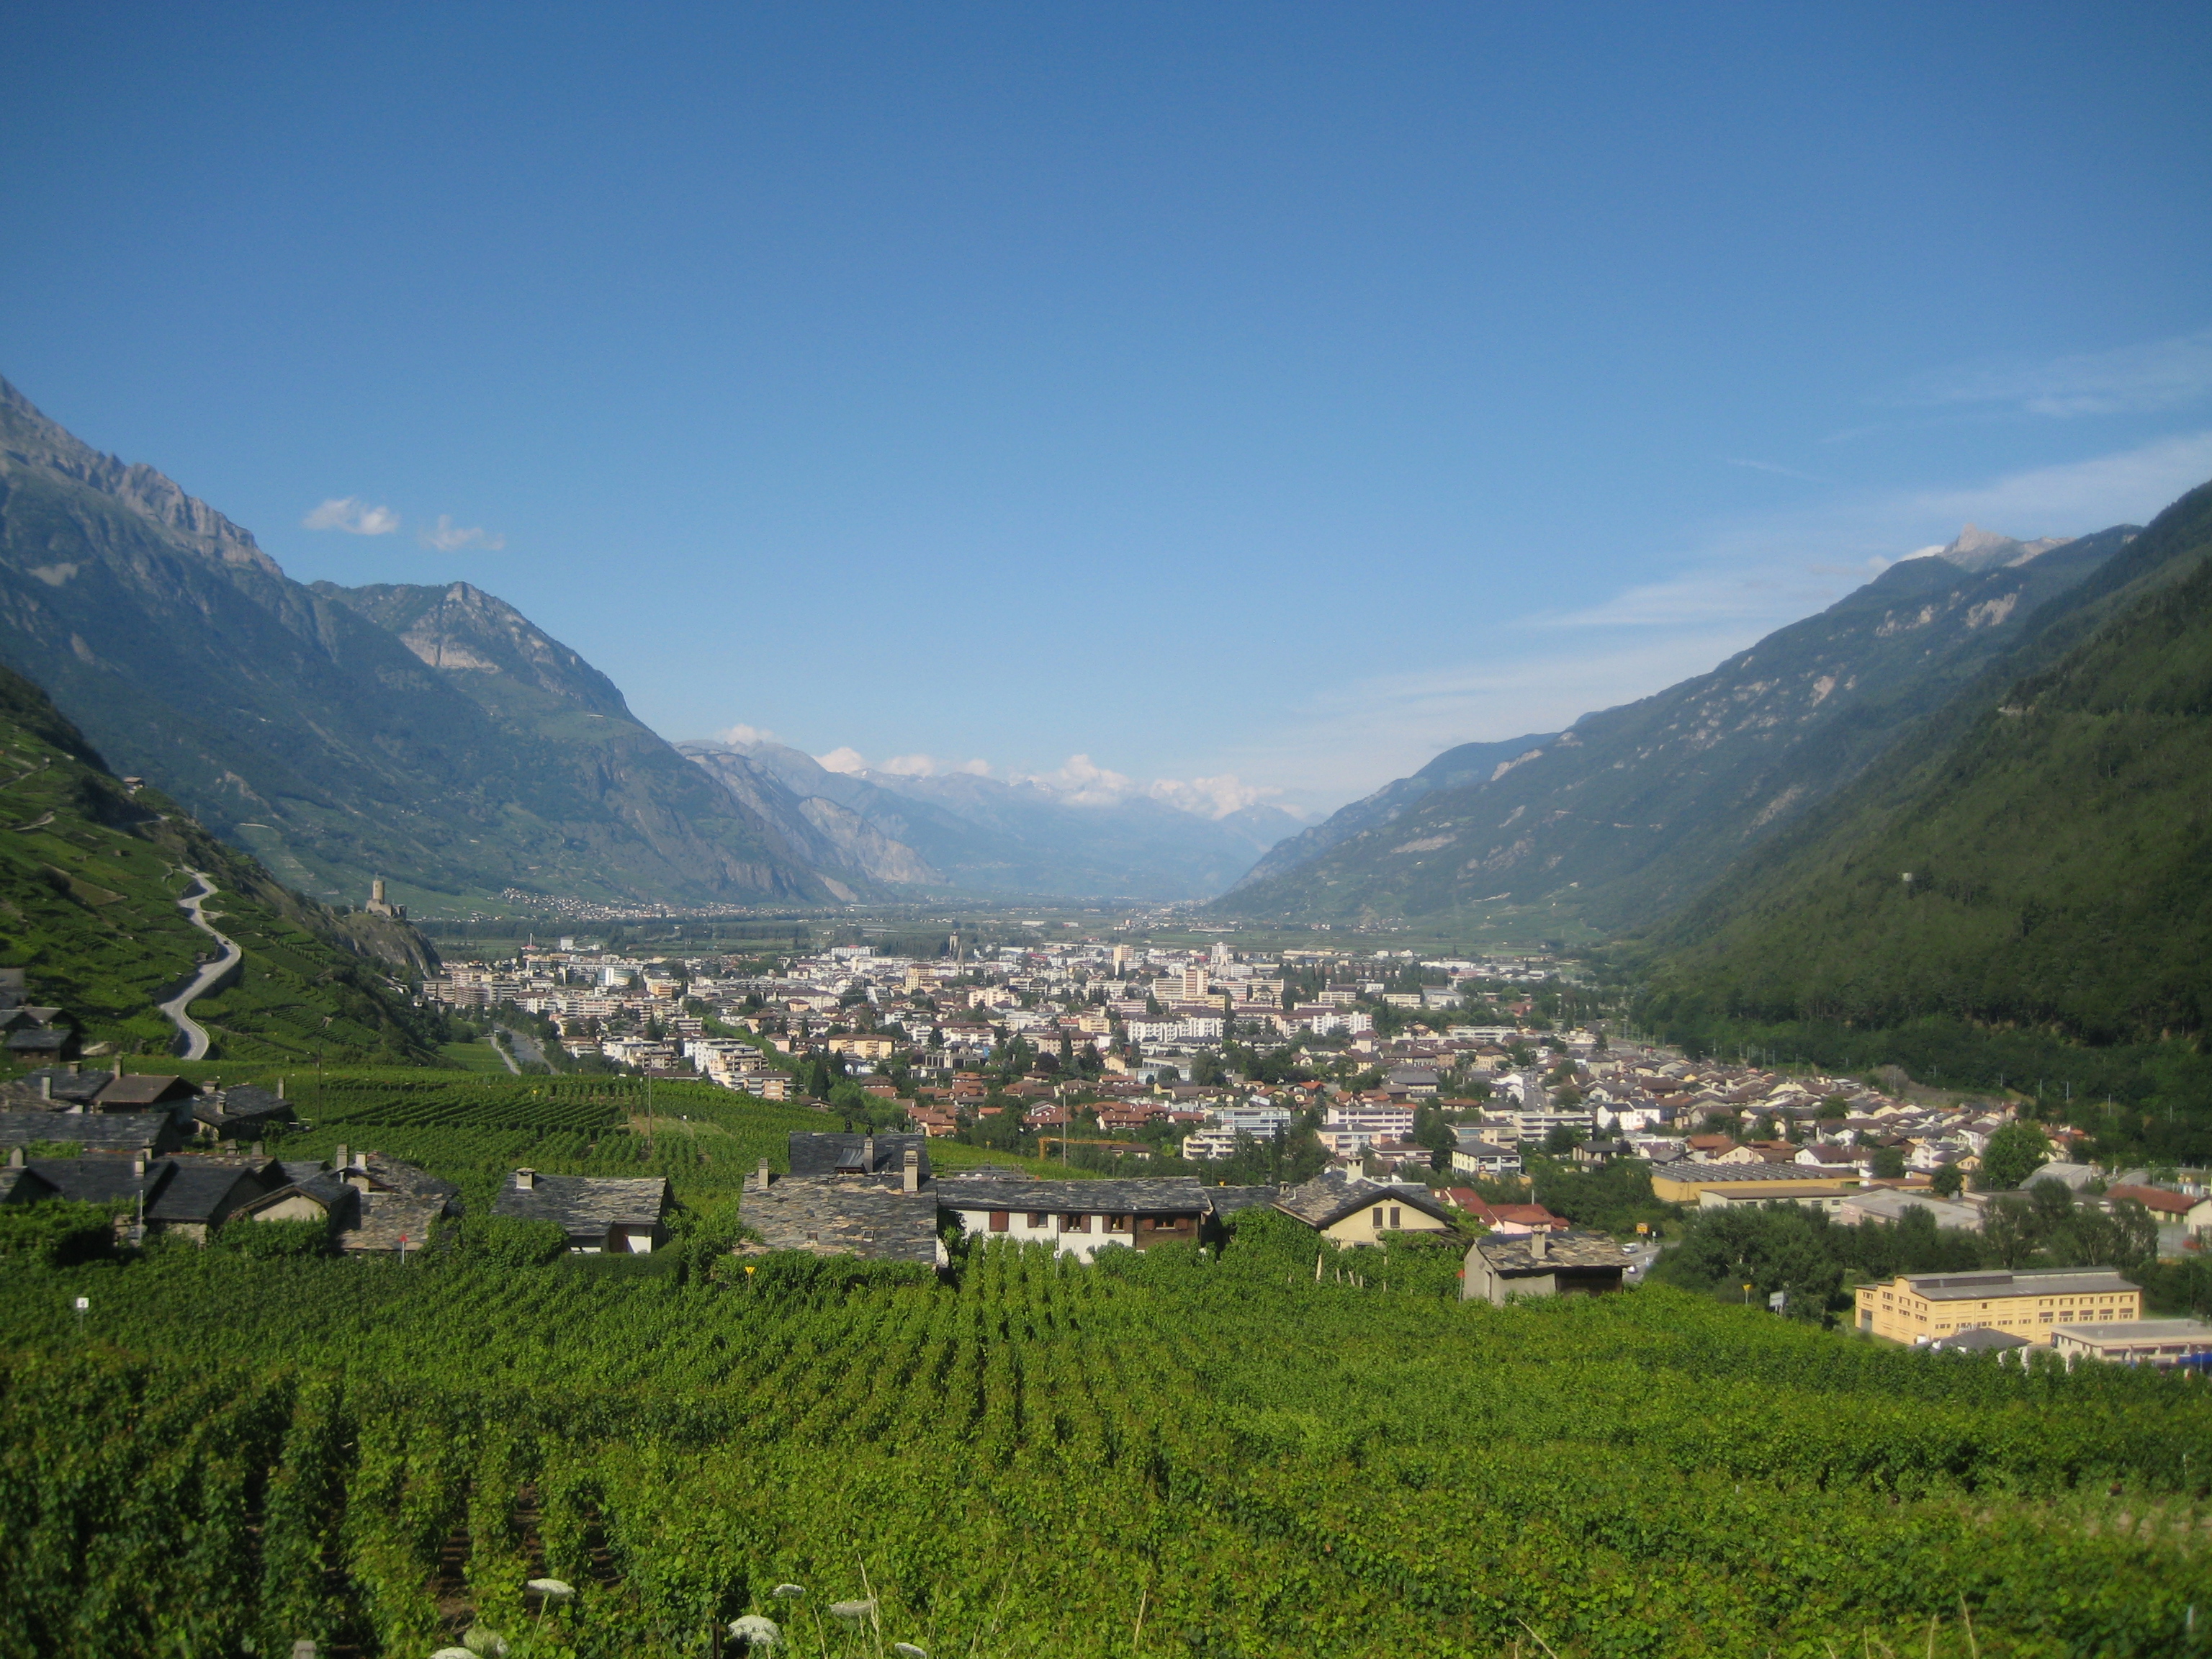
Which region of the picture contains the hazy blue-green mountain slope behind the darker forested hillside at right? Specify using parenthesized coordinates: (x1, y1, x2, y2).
(1217, 526, 2132, 929)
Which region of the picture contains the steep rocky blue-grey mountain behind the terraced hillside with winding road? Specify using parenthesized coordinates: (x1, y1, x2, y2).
(0, 382, 850, 907)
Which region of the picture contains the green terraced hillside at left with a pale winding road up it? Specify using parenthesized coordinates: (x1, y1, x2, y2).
(0, 668, 436, 1064)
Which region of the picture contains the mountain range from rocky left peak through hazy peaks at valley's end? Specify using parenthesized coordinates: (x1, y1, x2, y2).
(0, 380, 1296, 909)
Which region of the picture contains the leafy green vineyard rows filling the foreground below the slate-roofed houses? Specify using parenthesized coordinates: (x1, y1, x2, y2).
(0, 1185, 2212, 1659)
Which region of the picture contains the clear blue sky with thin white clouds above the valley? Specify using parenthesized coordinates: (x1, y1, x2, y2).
(0, 2, 2212, 809)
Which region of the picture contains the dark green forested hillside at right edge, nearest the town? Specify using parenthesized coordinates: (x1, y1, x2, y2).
(1646, 485, 2212, 1139)
